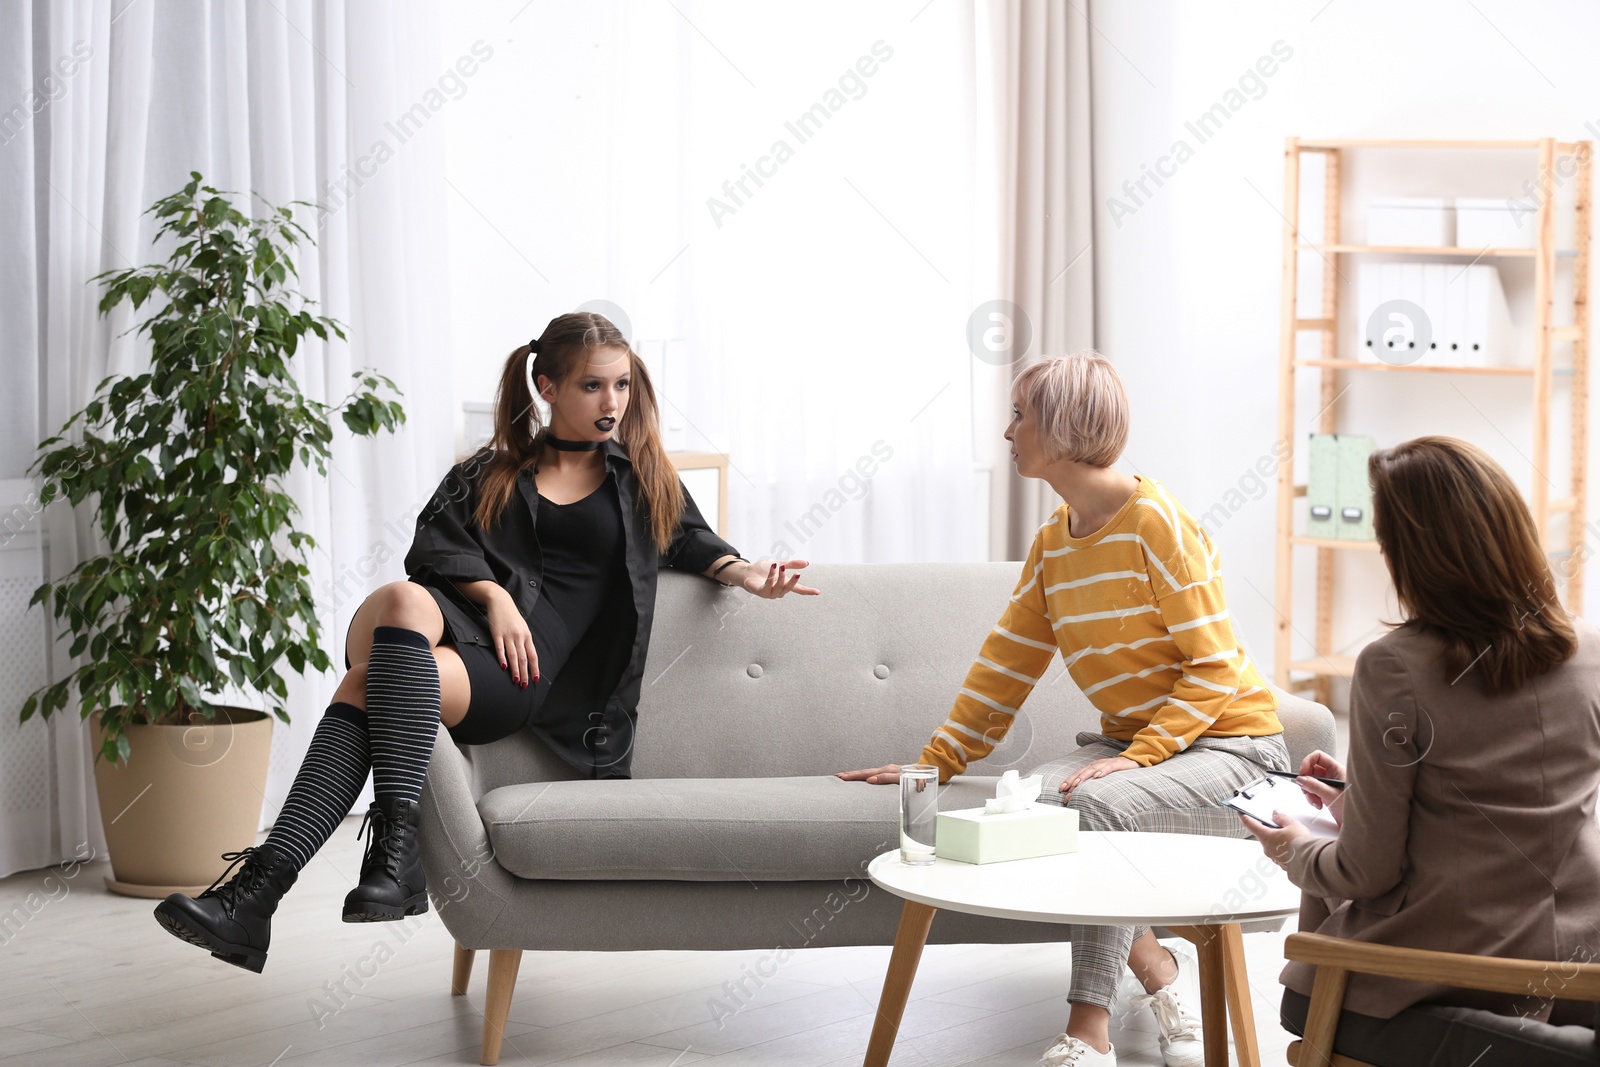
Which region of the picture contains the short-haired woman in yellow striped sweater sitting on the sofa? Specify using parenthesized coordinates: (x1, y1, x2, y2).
(840, 354, 1288, 1067)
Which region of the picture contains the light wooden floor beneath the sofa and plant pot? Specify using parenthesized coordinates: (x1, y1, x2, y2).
(0, 817, 1288, 1067)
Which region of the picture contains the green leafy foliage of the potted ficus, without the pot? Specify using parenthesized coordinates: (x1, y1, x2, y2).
(19, 171, 403, 742)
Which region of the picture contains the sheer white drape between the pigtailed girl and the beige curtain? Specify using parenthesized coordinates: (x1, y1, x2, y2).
(656, 3, 987, 566)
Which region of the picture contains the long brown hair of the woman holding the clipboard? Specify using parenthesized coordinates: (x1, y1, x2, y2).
(1366, 437, 1578, 694)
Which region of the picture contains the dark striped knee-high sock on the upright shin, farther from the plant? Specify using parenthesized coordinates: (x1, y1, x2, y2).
(366, 625, 440, 801)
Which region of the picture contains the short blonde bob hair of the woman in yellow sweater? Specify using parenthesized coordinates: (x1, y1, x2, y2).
(1011, 350, 1128, 467)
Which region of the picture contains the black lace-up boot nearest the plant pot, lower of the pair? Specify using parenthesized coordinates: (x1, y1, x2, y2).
(155, 845, 299, 974)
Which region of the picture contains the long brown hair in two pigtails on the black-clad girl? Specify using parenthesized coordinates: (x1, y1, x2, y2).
(470, 312, 683, 552)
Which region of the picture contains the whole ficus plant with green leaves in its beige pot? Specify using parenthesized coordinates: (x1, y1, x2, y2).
(21, 173, 405, 896)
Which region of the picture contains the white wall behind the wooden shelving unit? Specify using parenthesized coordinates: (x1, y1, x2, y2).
(1093, 0, 1600, 697)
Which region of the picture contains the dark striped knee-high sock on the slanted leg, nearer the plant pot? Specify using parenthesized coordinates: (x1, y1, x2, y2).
(266, 702, 371, 869)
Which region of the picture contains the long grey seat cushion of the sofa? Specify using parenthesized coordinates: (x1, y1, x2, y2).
(478, 776, 995, 881)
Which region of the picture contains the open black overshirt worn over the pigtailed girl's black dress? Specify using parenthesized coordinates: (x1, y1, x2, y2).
(405, 442, 738, 777)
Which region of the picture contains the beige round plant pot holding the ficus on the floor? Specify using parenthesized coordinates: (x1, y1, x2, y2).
(94, 707, 272, 897)
